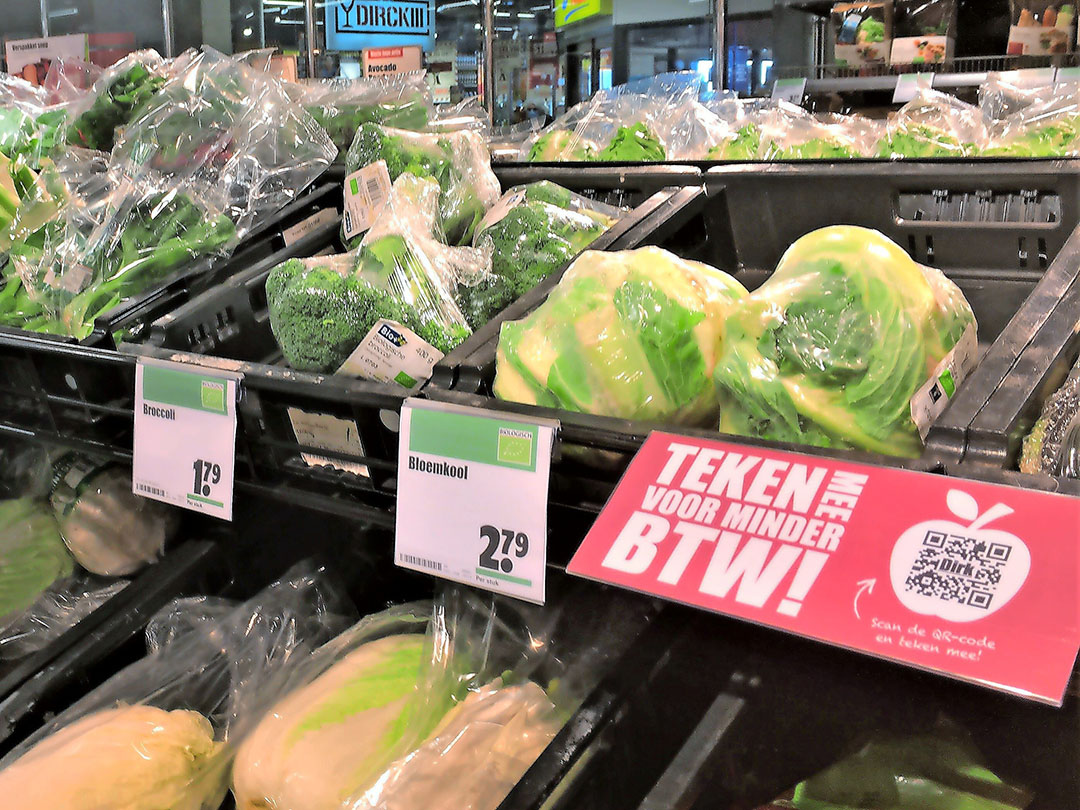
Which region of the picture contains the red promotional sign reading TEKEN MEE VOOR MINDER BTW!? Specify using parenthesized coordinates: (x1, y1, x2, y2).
(568, 433, 1080, 705)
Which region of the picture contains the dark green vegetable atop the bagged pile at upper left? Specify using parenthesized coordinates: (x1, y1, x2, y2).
(67, 51, 166, 152)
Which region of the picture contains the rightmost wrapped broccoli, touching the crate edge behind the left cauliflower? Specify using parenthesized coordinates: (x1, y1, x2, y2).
(458, 180, 621, 329)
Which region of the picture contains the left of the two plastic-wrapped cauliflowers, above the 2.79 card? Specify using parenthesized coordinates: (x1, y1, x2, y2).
(492, 247, 746, 423)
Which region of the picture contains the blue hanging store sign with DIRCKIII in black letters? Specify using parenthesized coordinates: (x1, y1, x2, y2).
(326, 0, 435, 51)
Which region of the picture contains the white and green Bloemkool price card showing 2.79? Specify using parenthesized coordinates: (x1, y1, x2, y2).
(394, 400, 558, 605)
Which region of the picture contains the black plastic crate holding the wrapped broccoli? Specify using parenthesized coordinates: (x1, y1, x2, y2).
(116, 186, 682, 509)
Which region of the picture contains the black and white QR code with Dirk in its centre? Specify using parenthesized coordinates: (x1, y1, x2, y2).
(904, 531, 1012, 610)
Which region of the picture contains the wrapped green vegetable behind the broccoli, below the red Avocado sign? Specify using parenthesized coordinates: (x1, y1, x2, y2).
(292, 75, 434, 152)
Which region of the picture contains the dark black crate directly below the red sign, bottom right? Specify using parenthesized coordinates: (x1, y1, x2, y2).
(617, 616, 1080, 810)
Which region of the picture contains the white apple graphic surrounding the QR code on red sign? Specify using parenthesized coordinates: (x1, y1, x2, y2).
(889, 489, 1031, 623)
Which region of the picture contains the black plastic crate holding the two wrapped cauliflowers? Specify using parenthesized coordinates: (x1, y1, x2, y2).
(424, 162, 1080, 511)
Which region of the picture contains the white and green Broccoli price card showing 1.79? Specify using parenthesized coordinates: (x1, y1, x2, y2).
(132, 357, 241, 521)
